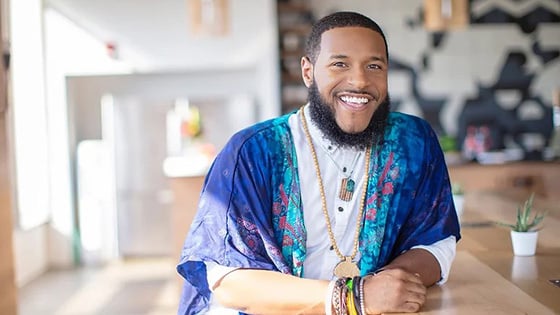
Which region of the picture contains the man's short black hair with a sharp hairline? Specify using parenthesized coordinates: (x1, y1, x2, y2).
(305, 11, 389, 63)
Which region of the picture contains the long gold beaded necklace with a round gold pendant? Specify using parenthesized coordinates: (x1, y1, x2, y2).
(300, 107, 371, 278)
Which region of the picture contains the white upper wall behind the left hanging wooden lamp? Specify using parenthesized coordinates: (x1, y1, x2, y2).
(46, 0, 277, 72)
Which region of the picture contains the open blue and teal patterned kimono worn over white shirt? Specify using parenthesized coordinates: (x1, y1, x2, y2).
(177, 112, 460, 314)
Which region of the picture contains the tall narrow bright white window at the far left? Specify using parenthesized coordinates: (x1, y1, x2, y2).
(8, 0, 50, 284)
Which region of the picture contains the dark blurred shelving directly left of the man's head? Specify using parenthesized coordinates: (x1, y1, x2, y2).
(277, 0, 314, 113)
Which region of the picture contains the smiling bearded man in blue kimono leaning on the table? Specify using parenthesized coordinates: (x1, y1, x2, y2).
(178, 12, 460, 314)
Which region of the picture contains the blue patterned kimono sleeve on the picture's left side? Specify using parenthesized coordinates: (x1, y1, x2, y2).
(177, 124, 288, 314)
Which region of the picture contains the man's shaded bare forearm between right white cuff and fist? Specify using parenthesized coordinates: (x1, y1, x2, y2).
(383, 249, 441, 286)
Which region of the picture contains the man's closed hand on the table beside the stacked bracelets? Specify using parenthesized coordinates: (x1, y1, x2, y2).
(364, 268, 426, 314)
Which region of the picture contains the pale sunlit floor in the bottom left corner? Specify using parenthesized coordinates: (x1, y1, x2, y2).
(18, 258, 179, 315)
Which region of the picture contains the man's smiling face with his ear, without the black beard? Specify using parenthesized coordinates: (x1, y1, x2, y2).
(302, 27, 388, 134)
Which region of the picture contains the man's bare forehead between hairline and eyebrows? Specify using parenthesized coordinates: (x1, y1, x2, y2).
(319, 26, 386, 59)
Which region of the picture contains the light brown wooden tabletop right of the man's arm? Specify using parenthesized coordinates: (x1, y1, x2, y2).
(406, 193, 560, 315)
